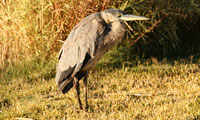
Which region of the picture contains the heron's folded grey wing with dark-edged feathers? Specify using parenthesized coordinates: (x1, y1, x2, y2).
(56, 13, 105, 93)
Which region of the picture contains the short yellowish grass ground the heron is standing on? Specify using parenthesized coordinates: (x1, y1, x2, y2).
(0, 61, 200, 120)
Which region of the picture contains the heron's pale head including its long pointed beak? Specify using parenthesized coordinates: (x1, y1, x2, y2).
(102, 9, 149, 23)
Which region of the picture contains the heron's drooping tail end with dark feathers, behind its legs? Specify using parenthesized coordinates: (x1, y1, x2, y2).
(56, 68, 73, 94)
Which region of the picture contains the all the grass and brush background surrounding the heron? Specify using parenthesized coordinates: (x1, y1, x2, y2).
(0, 0, 200, 120)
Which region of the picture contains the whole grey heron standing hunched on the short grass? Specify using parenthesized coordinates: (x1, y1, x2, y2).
(56, 9, 148, 110)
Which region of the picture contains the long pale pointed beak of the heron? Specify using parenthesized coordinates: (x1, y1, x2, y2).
(120, 14, 149, 21)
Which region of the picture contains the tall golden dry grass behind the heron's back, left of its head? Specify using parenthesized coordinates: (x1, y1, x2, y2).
(0, 0, 110, 69)
